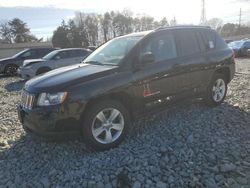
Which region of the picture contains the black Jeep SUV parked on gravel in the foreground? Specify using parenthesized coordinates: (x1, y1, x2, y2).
(18, 26, 235, 150)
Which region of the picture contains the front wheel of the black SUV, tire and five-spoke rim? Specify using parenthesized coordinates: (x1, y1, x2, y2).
(82, 100, 130, 150)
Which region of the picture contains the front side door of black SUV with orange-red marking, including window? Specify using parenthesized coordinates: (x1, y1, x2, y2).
(134, 31, 178, 103)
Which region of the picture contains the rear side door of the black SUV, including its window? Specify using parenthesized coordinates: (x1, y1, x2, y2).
(172, 29, 208, 95)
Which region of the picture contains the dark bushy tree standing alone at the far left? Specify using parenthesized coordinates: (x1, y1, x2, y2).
(0, 18, 39, 44)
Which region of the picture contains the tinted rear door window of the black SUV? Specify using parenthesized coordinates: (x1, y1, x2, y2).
(177, 30, 200, 56)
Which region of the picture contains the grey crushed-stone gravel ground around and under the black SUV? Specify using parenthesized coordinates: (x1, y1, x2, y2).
(0, 59, 250, 188)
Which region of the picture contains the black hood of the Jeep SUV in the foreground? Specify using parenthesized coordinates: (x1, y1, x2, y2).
(24, 64, 117, 93)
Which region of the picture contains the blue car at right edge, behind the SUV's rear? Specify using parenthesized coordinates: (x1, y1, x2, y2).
(228, 39, 250, 57)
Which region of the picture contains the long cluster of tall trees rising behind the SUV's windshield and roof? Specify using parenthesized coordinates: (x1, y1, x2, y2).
(52, 10, 177, 47)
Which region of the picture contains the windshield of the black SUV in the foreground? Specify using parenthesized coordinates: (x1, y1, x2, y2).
(83, 36, 143, 66)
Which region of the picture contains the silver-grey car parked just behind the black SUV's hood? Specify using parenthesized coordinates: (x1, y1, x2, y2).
(18, 48, 91, 79)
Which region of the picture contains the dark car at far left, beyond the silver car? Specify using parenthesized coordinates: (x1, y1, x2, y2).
(0, 48, 55, 75)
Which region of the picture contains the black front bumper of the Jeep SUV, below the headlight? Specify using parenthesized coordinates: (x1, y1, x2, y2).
(17, 105, 81, 140)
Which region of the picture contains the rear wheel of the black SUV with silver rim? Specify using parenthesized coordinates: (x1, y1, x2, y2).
(206, 73, 227, 107)
